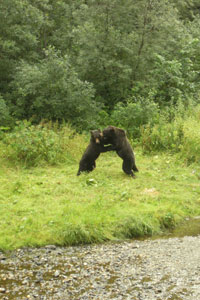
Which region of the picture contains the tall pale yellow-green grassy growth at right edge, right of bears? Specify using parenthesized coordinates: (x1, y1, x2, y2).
(140, 106, 200, 163)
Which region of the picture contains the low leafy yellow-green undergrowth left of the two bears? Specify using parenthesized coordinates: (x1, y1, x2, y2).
(2, 121, 84, 167)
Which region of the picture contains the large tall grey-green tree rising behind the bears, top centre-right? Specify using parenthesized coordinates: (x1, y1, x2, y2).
(68, 0, 186, 109)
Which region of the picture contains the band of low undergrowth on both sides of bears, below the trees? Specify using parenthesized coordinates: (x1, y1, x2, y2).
(0, 100, 200, 167)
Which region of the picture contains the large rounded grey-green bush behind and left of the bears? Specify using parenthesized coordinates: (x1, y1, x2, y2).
(11, 48, 99, 130)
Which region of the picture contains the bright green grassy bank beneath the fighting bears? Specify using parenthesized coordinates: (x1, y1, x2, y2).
(0, 149, 200, 250)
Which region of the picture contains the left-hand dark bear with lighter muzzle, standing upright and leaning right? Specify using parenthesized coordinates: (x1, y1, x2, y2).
(77, 129, 115, 176)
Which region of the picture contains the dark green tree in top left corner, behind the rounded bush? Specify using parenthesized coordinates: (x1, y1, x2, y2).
(0, 0, 48, 93)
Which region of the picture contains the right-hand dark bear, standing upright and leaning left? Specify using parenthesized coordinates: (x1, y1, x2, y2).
(103, 126, 138, 177)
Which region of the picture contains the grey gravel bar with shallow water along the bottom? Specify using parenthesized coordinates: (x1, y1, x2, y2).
(0, 236, 200, 300)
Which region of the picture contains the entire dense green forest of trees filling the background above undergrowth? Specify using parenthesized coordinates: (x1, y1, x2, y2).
(0, 0, 200, 132)
